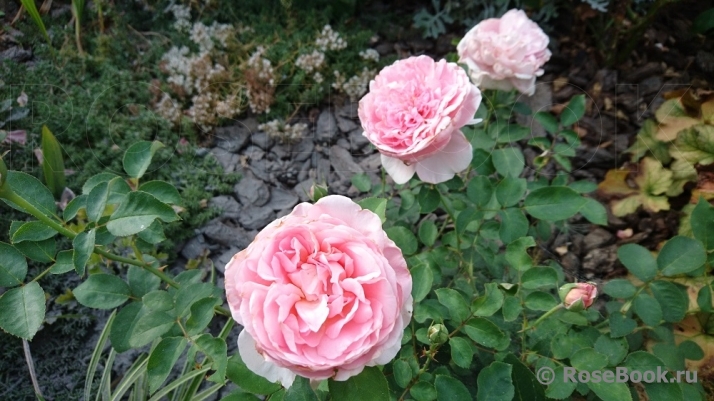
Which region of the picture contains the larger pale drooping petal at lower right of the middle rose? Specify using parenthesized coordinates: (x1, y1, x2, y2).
(416, 132, 473, 184)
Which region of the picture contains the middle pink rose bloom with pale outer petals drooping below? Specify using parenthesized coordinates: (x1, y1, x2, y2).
(359, 56, 481, 184)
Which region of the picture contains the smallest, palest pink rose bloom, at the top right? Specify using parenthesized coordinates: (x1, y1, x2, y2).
(456, 10, 550, 96)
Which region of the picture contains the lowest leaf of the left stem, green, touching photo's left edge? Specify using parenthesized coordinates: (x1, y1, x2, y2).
(0, 281, 45, 340)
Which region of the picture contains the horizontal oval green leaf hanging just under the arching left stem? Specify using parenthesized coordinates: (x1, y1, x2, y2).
(72, 273, 131, 309)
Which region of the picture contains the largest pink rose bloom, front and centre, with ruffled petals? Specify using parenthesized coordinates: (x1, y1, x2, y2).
(225, 195, 413, 386)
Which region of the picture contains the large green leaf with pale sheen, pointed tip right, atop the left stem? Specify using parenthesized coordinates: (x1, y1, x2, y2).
(107, 191, 179, 237)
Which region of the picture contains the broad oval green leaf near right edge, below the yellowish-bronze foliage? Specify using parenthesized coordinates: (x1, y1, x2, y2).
(657, 236, 707, 276)
